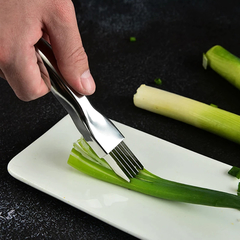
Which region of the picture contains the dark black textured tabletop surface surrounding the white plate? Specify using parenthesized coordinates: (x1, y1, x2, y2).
(0, 0, 240, 240)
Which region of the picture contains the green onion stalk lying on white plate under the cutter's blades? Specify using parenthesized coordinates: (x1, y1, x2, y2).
(68, 138, 240, 210)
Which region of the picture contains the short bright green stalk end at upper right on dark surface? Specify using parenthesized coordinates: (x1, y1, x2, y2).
(203, 45, 240, 89)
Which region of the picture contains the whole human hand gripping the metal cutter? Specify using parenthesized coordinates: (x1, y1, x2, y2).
(0, 0, 95, 101)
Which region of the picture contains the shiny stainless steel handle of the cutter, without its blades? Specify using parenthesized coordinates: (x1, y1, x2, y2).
(38, 39, 124, 157)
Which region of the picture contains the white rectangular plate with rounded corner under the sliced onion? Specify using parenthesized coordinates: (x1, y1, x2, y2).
(8, 116, 240, 240)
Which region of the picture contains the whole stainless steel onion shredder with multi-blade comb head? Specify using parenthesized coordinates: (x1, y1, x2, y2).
(37, 39, 143, 182)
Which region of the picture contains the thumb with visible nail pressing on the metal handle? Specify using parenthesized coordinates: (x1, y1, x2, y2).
(45, 1, 95, 95)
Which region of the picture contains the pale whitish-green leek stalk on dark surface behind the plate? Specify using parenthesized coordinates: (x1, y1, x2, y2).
(133, 85, 240, 144)
